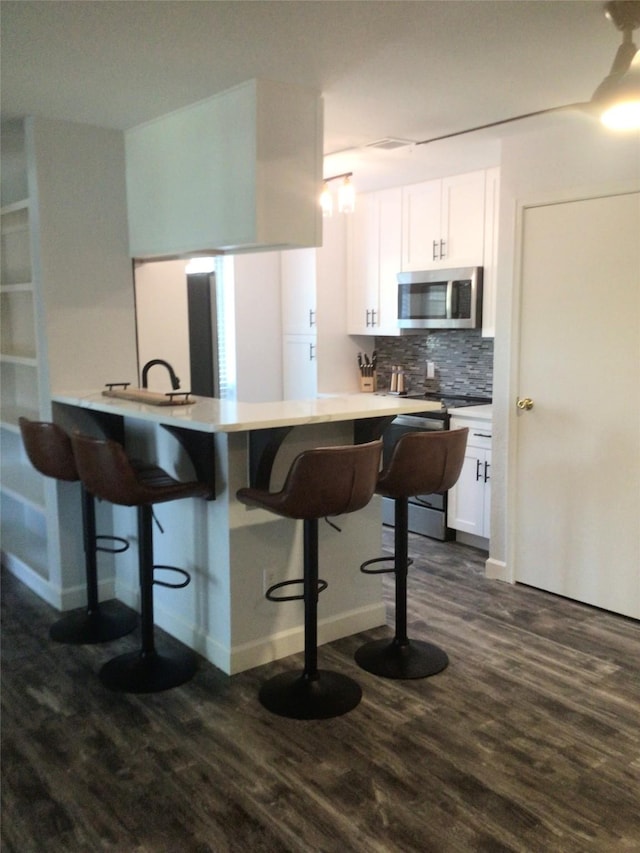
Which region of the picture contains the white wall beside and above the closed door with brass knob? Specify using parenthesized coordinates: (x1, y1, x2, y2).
(490, 114, 640, 574)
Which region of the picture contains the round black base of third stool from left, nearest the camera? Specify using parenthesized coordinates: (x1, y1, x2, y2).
(258, 669, 362, 720)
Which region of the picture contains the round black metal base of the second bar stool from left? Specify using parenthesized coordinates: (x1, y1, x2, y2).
(99, 651, 198, 693)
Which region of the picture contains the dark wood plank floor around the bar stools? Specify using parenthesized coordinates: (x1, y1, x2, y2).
(2, 535, 640, 853)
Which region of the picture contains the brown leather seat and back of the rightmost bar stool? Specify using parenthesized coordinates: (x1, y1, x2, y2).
(376, 428, 469, 498)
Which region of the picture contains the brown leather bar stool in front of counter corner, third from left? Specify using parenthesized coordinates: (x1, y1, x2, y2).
(237, 441, 382, 720)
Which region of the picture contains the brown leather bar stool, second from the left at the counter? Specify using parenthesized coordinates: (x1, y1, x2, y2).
(71, 433, 211, 693)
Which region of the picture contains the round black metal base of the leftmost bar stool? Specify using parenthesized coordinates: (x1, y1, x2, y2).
(49, 598, 138, 645)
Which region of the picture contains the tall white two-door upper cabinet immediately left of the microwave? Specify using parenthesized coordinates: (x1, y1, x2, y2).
(347, 187, 402, 336)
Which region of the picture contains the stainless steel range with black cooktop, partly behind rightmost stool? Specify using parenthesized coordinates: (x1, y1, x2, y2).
(382, 394, 491, 542)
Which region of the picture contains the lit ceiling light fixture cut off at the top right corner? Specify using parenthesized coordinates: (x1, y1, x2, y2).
(591, 0, 640, 130)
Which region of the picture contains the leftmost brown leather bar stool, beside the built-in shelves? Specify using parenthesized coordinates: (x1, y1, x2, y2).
(19, 418, 138, 644)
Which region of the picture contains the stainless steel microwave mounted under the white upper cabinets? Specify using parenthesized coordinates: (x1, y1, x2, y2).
(398, 267, 482, 329)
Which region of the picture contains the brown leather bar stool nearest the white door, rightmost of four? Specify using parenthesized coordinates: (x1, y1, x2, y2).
(355, 428, 469, 678)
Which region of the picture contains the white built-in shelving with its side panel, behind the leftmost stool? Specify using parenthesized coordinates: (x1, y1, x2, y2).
(0, 118, 136, 608)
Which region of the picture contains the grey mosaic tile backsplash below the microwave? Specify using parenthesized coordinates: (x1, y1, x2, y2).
(376, 329, 493, 397)
